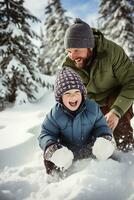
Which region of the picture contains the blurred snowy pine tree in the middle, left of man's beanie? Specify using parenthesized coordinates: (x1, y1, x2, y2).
(39, 0, 70, 75)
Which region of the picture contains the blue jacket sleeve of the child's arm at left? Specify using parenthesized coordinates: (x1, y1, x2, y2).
(38, 110, 60, 150)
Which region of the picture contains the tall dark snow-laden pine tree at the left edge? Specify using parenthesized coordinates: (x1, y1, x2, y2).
(0, 0, 40, 108)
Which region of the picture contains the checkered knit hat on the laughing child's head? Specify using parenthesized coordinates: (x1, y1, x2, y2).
(54, 67, 87, 103)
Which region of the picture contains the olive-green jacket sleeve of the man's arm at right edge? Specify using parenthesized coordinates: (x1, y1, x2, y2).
(111, 45, 134, 116)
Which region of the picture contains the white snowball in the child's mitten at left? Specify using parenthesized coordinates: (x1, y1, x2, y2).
(50, 147, 74, 169)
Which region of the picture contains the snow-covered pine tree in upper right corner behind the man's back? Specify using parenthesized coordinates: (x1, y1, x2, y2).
(99, 0, 134, 60)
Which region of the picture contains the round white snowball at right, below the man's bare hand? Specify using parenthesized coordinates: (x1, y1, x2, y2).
(92, 137, 115, 160)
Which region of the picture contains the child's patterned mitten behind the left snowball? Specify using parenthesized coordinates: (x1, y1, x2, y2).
(44, 143, 62, 160)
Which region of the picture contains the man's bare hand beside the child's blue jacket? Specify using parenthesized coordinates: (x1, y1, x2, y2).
(105, 110, 119, 131)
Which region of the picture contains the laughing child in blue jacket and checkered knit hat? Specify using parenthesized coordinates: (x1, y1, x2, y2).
(38, 67, 112, 174)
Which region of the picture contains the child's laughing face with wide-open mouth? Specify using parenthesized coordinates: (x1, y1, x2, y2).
(62, 89, 82, 111)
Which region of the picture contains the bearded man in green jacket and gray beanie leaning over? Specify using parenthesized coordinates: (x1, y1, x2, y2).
(63, 18, 134, 151)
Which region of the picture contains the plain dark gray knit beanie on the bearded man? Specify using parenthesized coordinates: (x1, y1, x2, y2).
(64, 18, 94, 49)
